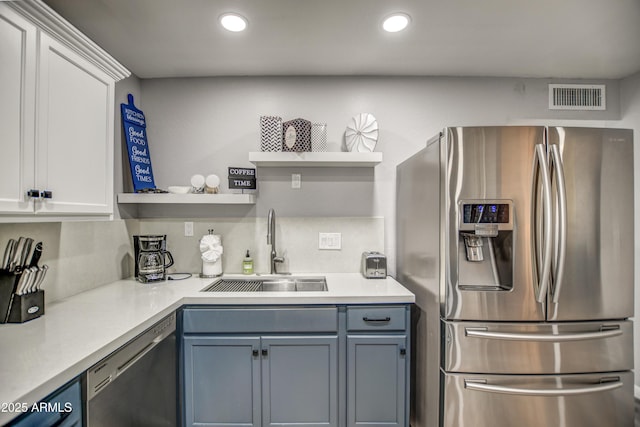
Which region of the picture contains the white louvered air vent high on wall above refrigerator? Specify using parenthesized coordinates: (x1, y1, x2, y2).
(549, 84, 607, 110)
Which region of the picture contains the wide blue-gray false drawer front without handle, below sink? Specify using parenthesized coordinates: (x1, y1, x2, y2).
(183, 307, 338, 333)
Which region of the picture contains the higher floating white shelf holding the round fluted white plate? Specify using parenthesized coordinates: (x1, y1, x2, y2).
(249, 151, 382, 168)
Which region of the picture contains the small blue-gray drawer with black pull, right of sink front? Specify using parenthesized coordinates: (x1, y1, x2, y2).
(347, 306, 407, 331)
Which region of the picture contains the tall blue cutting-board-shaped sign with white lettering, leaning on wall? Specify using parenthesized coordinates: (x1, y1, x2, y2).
(120, 94, 156, 192)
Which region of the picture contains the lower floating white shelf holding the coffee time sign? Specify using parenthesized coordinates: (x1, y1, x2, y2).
(118, 193, 256, 205)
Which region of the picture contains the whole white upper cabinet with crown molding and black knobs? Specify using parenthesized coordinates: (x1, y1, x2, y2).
(0, 0, 129, 221)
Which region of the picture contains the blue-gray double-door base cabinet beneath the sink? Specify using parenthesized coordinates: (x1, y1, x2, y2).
(182, 308, 338, 427)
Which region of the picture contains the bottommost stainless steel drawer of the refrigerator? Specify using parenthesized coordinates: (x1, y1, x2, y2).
(442, 371, 634, 427)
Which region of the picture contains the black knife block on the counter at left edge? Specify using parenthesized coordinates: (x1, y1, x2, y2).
(0, 270, 44, 323)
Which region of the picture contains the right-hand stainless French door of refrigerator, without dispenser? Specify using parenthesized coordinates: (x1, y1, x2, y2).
(547, 127, 634, 321)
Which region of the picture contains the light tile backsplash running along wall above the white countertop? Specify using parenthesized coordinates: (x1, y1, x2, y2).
(0, 217, 384, 303)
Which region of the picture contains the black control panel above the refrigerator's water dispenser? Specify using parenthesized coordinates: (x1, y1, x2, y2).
(459, 200, 513, 234)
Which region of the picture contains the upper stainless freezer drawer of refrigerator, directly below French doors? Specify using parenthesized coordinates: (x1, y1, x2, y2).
(442, 320, 633, 374)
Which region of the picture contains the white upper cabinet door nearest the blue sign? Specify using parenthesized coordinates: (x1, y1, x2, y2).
(35, 33, 115, 214)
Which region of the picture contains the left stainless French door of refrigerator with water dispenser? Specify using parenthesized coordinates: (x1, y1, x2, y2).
(440, 126, 545, 321)
